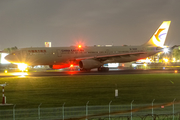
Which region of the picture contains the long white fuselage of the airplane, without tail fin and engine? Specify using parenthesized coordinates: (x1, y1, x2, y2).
(6, 46, 160, 65)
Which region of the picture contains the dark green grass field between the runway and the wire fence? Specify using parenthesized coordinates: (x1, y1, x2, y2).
(0, 74, 180, 108)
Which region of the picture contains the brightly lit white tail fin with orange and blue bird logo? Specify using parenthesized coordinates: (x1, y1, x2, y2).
(143, 21, 171, 47)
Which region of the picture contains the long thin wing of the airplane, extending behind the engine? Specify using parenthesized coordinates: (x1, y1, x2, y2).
(76, 52, 146, 61)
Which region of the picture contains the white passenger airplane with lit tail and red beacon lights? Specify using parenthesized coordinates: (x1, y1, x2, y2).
(5, 21, 171, 71)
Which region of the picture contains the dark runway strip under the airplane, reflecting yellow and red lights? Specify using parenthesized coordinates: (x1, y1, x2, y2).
(0, 70, 180, 77)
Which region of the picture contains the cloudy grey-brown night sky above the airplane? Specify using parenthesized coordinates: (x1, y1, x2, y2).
(0, 0, 180, 50)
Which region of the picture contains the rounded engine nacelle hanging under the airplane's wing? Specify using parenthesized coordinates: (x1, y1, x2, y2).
(79, 59, 103, 70)
